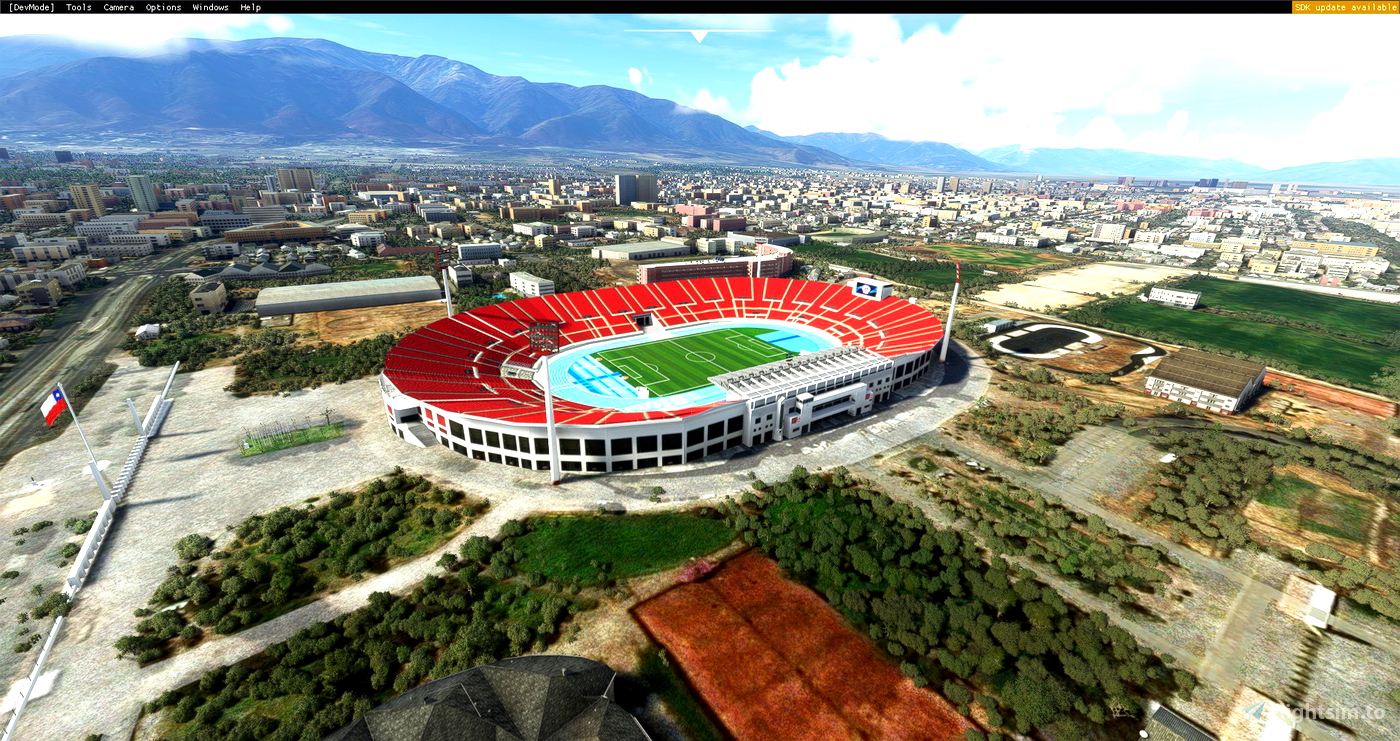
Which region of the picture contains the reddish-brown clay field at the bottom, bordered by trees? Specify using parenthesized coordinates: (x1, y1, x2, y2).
(634, 550, 970, 741)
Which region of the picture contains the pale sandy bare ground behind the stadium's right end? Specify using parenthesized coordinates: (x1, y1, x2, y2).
(977, 262, 1194, 311)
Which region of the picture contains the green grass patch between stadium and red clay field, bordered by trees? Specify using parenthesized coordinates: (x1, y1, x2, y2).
(511, 513, 734, 586)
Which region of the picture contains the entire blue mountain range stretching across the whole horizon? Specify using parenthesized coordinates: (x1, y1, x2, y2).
(0, 35, 1400, 185)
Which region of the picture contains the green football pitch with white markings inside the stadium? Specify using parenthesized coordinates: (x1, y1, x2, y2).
(594, 328, 797, 396)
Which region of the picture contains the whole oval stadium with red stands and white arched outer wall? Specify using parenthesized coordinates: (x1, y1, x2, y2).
(379, 277, 944, 480)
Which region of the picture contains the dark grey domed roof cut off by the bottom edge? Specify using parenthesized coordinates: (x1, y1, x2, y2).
(325, 656, 651, 741)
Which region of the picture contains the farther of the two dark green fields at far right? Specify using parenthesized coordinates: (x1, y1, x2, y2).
(1182, 277, 1400, 340)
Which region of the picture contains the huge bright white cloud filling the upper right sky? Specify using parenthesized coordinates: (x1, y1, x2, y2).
(736, 15, 1400, 167)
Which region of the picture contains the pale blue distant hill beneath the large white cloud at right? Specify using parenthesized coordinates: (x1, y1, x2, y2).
(977, 146, 1264, 179)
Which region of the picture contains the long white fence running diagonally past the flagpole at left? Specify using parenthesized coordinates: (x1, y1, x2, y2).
(0, 363, 179, 741)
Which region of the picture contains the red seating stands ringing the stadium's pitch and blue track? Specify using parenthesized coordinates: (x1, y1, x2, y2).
(384, 277, 944, 424)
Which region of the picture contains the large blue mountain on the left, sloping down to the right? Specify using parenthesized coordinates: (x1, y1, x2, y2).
(0, 36, 857, 167)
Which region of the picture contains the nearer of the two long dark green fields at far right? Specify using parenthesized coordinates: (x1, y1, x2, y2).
(1105, 298, 1400, 387)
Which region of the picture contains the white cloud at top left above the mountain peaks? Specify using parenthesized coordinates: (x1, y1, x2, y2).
(0, 14, 295, 49)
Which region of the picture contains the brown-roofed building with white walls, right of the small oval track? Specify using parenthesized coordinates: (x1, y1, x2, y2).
(1147, 347, 1266, 415)
